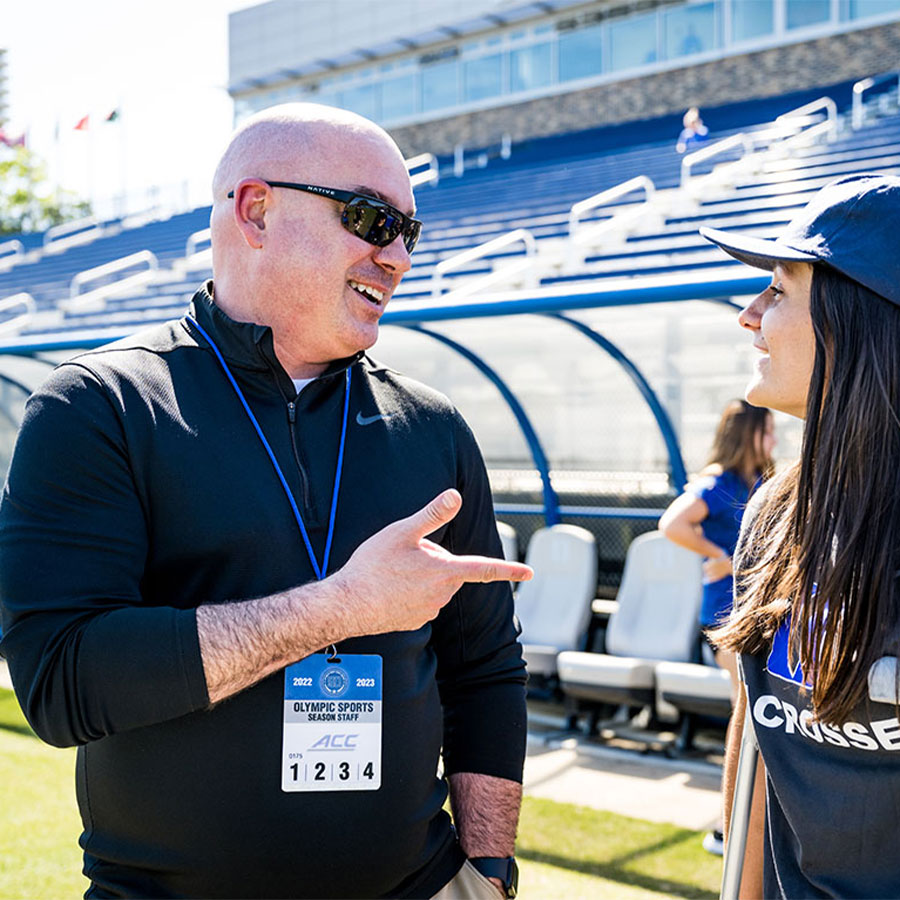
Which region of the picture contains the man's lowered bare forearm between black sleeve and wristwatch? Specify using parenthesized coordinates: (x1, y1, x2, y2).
(448, 772, 522, 857)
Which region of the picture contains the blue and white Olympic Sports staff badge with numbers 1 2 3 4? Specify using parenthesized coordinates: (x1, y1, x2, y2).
(281, 653, 382, 791)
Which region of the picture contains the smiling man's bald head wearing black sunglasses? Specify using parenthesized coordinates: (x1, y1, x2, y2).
(210, 103, 415, 377)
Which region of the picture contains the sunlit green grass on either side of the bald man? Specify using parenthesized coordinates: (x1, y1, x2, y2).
(0, 689, 721, 900)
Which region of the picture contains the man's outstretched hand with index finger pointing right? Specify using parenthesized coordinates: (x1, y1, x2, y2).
(327, 488, 534, 637)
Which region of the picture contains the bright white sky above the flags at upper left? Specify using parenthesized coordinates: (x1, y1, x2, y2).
(0, 0, 256, 211)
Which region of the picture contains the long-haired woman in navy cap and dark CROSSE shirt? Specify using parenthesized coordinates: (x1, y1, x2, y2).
(702, 174, 900, 897)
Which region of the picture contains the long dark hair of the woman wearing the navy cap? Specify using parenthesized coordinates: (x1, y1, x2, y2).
(712, 264, 900, 724)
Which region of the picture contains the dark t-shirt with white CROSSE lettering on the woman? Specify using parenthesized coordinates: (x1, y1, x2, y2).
(741, 636, 900, 898)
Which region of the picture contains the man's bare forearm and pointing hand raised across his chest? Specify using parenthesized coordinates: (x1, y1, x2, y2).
(196, 490, 531, 703)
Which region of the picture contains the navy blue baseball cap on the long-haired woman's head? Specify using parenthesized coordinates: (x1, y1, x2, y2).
(700, 174, 900, 306)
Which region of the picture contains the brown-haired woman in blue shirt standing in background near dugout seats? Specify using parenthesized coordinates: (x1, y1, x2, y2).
(659, 400, 775, 855)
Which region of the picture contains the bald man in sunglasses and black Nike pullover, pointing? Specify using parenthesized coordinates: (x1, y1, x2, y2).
(0, 104, 530, 898)
